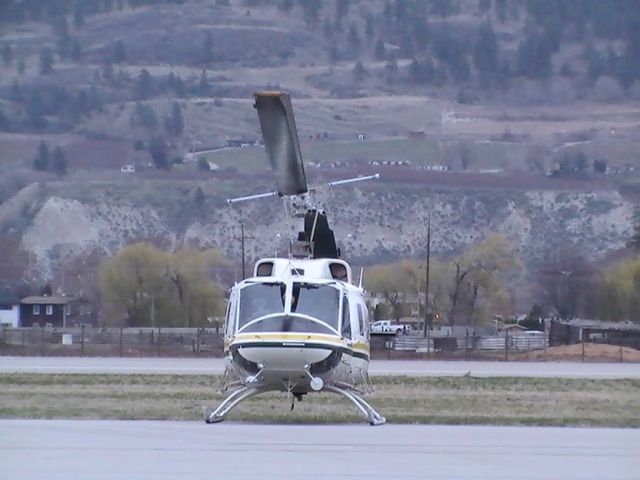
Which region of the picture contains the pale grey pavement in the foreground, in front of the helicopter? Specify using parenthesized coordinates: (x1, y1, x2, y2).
(0, 420, 640, 480)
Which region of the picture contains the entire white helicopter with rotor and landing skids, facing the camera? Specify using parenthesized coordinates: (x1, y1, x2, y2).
(205, 92, 386, 425)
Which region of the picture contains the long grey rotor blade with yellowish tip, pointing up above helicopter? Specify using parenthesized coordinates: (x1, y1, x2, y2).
(254, 92, 308, 195)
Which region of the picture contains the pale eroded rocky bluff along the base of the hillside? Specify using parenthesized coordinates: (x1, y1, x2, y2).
(6, 178, 633, 277)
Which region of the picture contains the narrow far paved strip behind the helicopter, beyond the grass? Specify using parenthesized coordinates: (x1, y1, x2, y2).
(0, 357, 640, 379)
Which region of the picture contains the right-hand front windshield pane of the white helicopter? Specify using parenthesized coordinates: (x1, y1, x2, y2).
(291, 282, 340, 330)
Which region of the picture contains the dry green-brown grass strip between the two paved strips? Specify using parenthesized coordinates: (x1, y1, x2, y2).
(0, 374, 640, 427)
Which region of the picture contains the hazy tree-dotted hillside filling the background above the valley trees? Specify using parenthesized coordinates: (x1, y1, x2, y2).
(0, 0, 640, 294)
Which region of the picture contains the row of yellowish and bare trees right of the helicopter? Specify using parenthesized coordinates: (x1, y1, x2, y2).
(365, 231, 640, 326)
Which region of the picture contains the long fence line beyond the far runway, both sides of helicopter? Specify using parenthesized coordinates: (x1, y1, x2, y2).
(0, 326, 640, 362)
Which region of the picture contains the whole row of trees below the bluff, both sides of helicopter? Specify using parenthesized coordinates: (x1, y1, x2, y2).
(6, 228, 640, 327)
